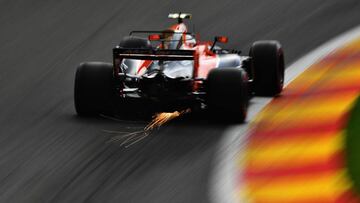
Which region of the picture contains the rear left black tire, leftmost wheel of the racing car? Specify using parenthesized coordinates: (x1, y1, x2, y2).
(74, 62, 114, 116)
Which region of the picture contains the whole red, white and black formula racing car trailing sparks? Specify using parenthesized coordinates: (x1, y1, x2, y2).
(75, 13, 284, 122)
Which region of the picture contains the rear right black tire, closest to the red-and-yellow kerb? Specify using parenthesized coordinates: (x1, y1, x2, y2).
(206, 68, 249, 123)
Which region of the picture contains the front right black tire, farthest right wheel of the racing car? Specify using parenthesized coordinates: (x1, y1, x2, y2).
(249, 41, 285, 96)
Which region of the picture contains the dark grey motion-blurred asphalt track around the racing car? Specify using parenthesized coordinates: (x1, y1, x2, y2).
(0, 0, 360, 202)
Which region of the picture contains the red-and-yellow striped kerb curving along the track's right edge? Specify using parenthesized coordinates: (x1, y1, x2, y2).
(238, 30, 360, 202)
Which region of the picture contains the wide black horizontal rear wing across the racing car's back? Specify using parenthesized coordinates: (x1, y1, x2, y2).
(113, 48, 195, 61)
